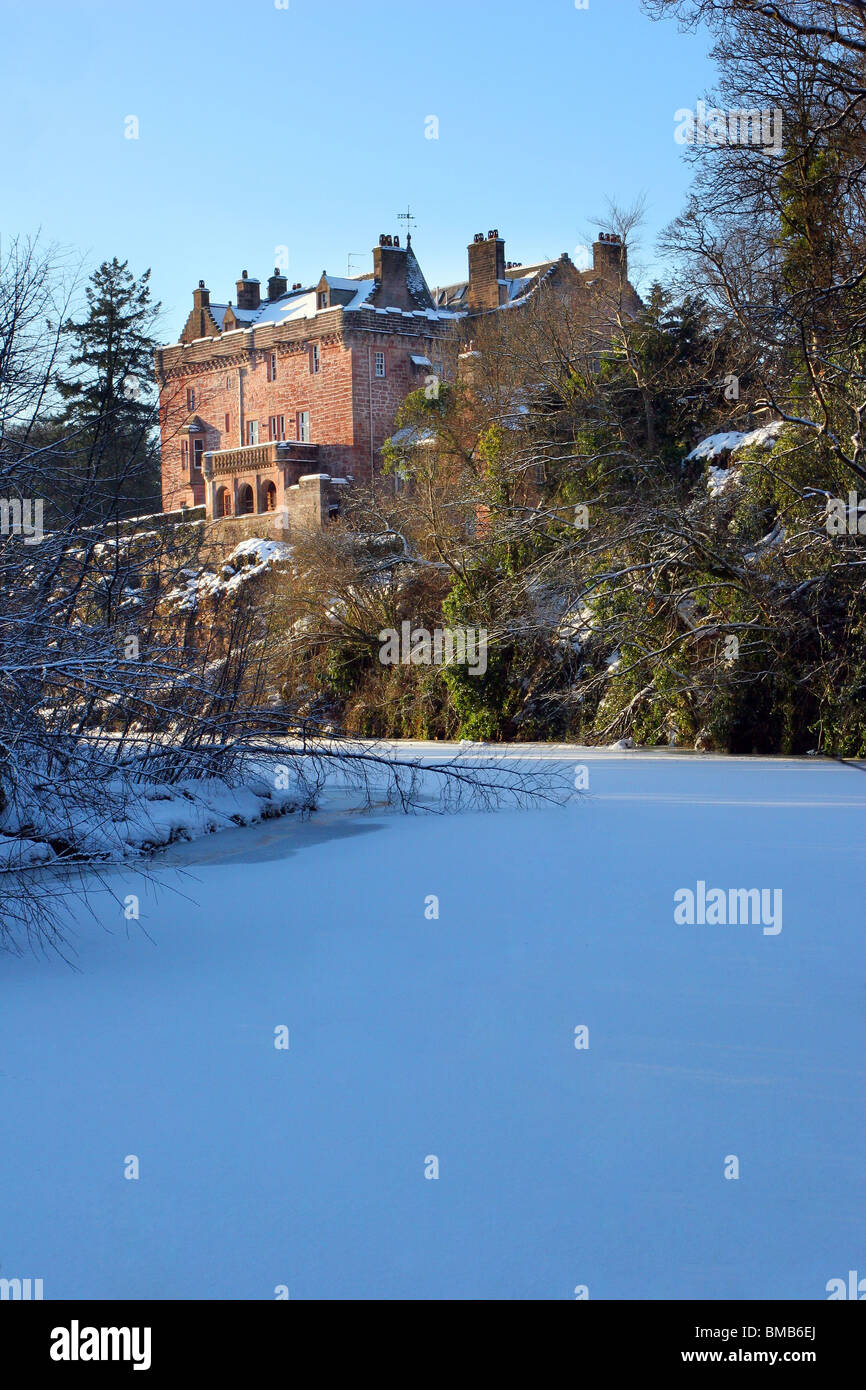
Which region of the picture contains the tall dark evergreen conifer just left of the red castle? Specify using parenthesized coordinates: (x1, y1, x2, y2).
(58, 257, 161, 521)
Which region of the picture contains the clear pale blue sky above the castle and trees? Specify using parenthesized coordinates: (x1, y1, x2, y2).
(0, 0, 713, 341)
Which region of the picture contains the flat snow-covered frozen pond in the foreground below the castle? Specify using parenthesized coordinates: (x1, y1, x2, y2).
(0, 748, 866, 1300)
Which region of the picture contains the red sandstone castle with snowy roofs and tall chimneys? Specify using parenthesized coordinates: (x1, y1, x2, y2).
(156, 232, 637, 530)
